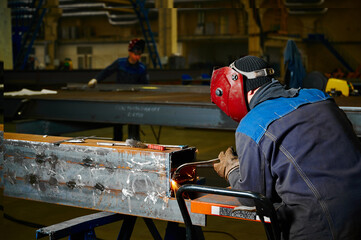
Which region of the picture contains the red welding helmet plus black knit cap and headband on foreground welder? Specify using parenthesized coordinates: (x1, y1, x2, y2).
(211, 56, 274, 122)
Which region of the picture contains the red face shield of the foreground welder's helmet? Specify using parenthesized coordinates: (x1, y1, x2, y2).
(211, 67, 248, 122)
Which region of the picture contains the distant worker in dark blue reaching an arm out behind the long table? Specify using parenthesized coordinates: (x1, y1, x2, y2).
(88, 38, 149, 141)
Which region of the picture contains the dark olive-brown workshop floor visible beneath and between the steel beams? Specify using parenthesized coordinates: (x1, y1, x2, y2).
(0, 126, 266, 240)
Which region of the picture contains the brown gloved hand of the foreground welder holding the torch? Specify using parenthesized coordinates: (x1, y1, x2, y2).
(213, 147, 239, 180)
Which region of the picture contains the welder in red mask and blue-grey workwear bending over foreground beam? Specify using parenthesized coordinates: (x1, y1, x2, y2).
(211, 56, 361, 240)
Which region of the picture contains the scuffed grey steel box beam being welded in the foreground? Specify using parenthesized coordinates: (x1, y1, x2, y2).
(3, 133, 205, 226)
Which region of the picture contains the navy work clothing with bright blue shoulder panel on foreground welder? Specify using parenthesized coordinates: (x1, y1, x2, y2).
(228, 89, 361, 240)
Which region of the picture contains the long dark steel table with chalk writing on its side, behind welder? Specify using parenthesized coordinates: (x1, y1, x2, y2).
(4, 84, 361, 136)
